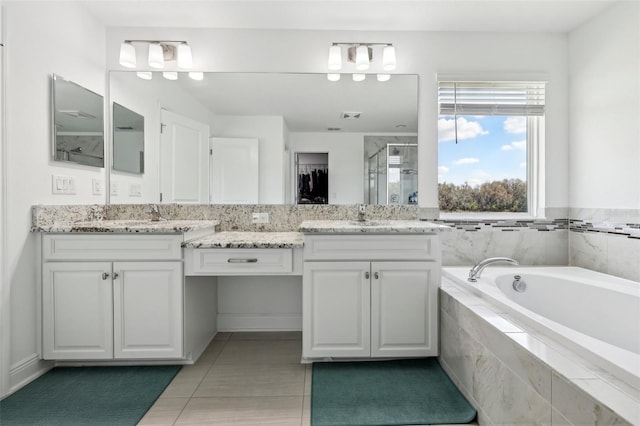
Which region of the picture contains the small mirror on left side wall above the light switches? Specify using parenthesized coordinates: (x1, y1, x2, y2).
(51, 74, 104, 167)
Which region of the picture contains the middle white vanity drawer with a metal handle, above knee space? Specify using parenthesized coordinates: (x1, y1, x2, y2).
(185, 248, 293, 275)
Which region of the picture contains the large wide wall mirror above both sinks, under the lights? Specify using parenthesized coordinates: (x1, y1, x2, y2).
(109, 71, 418, 204)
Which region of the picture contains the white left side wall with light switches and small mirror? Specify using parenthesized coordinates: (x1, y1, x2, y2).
(2, 2, 106, 392)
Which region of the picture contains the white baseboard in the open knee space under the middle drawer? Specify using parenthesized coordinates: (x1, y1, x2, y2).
(218, 314, 302, 332)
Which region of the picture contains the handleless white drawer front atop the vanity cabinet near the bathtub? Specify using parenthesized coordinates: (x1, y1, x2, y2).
(304, 234, 440, 261)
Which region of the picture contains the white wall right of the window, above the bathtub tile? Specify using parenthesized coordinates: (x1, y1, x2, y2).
(569, 1, 640, 209)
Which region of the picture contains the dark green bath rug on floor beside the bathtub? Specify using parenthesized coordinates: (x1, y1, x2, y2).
(311, 358, 476, 426)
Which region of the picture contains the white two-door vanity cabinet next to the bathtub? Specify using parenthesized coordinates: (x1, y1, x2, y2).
(302, 234, 440, 358)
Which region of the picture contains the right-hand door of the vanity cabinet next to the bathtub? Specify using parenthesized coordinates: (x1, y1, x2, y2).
(371, 262, 440, 357)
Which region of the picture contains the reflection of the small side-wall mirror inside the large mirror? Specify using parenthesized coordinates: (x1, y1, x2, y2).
(112, 102, 144, 174)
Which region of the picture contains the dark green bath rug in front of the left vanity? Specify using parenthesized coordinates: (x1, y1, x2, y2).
(0, 366, 181, 426)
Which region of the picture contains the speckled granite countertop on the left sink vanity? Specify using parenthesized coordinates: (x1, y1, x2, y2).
(31, 220, 220, 234)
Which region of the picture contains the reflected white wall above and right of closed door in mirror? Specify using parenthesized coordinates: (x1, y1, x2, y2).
(211, 115, 285, 204)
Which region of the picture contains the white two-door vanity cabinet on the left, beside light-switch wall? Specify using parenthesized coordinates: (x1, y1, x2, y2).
(42, 234, 183, 360)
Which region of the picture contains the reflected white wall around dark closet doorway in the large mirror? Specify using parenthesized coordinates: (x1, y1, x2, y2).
(289, 132, 364, 204)
